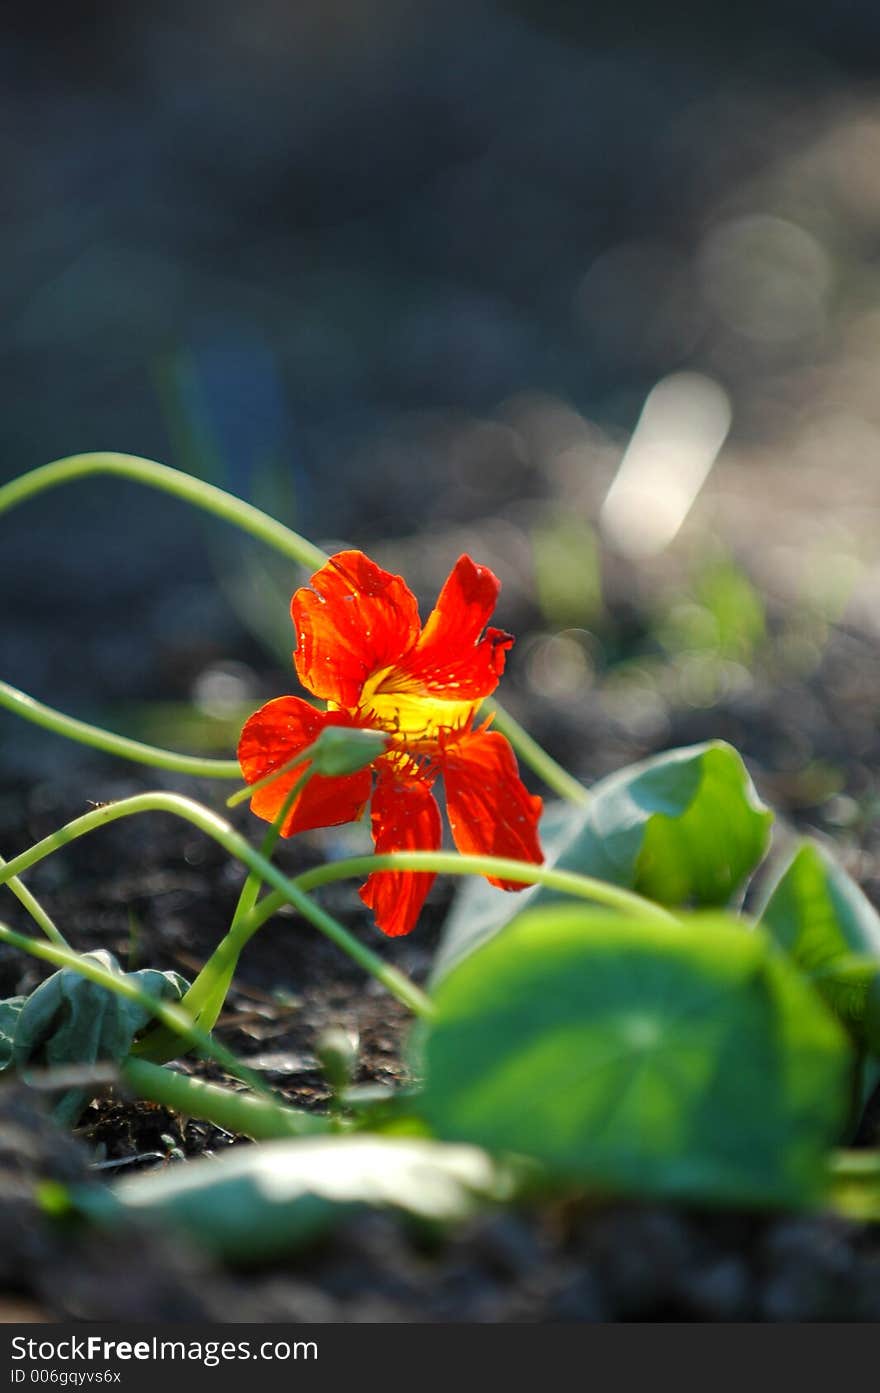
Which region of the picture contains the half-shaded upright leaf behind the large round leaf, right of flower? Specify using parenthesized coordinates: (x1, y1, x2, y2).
(433, 741, 773, 982)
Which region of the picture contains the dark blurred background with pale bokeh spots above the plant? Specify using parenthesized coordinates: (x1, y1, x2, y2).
(0, 0, 880, 878)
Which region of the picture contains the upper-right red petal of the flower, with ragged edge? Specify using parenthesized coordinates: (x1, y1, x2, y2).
(398, 556, 514, 701)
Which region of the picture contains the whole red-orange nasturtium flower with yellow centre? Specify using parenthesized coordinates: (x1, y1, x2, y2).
(238, 552, 543, 936)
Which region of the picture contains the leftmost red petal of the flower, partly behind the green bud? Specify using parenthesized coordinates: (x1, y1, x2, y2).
(238, 697, 372, 837)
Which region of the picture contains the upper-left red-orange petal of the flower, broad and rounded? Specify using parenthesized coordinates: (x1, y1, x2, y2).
(291, 552, 419, 710)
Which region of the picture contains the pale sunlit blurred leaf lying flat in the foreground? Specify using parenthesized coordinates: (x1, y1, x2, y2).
(72, 1135, 512, 1262)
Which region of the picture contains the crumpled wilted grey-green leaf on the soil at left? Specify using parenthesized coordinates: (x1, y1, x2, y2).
(11, 949, 188, 1124)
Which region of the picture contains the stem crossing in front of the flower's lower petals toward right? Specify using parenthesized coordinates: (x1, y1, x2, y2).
(248, 851, 678, 933)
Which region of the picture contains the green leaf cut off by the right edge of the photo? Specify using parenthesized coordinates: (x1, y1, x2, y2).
(760, 841, 880, 1053)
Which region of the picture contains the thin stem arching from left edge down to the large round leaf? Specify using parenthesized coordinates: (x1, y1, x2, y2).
(0, 793, 433, 1015)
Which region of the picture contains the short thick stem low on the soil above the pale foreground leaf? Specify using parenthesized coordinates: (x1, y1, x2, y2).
(120, 1056, 331, 1141)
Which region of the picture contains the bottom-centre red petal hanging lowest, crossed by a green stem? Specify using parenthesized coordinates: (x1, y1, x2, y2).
(359, 772, 443, 937)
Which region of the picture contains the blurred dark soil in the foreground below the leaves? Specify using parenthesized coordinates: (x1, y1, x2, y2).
(0, 1087, 880, 1322)
